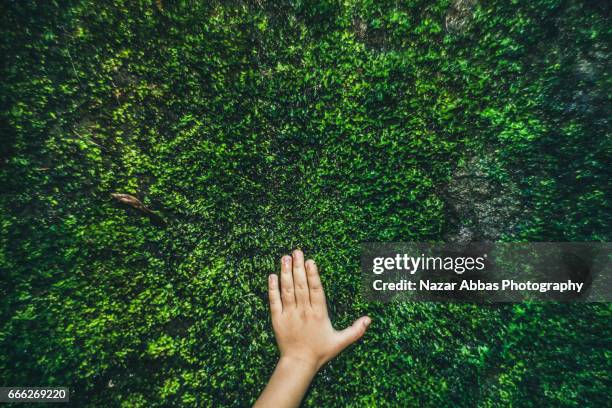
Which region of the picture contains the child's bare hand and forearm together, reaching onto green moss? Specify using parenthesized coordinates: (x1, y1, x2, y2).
(254, 249, 371, 408)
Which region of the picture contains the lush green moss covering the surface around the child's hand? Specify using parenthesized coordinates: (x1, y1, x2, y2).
(0, 0, 612, 407)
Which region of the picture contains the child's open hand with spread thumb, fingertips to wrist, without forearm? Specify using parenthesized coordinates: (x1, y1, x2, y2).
(268, 249, 371, 371)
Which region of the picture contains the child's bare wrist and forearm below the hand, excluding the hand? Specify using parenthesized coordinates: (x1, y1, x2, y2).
(254, 357, 318, 408)
